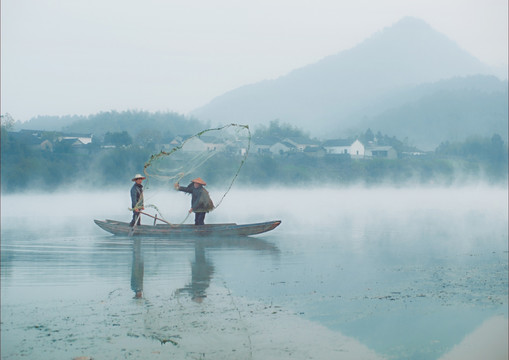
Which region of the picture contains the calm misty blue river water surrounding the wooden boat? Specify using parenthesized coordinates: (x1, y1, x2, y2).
(1, 187, 508, 359)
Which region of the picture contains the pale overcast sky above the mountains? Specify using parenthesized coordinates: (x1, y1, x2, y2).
(1, 0, 508, 121)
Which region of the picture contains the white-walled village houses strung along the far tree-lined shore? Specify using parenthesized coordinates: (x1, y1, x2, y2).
(9, 130, 398, 159)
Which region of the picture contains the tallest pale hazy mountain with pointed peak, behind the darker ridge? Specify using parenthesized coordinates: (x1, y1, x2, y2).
(192, 17, 502, 143)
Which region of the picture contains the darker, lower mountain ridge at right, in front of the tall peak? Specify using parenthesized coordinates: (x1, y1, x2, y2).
(364, 76, 509, 150)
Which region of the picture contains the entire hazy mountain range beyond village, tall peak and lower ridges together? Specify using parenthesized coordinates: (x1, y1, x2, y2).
(14, 18, 508, 150)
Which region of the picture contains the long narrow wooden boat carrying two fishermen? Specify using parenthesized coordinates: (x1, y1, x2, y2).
(94, 220, 281, 238)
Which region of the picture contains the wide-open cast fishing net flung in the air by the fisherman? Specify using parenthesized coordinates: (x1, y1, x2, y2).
(143, 124, 251, 222)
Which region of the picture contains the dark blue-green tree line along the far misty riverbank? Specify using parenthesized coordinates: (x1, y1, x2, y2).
(1, 116, 508, 193)
